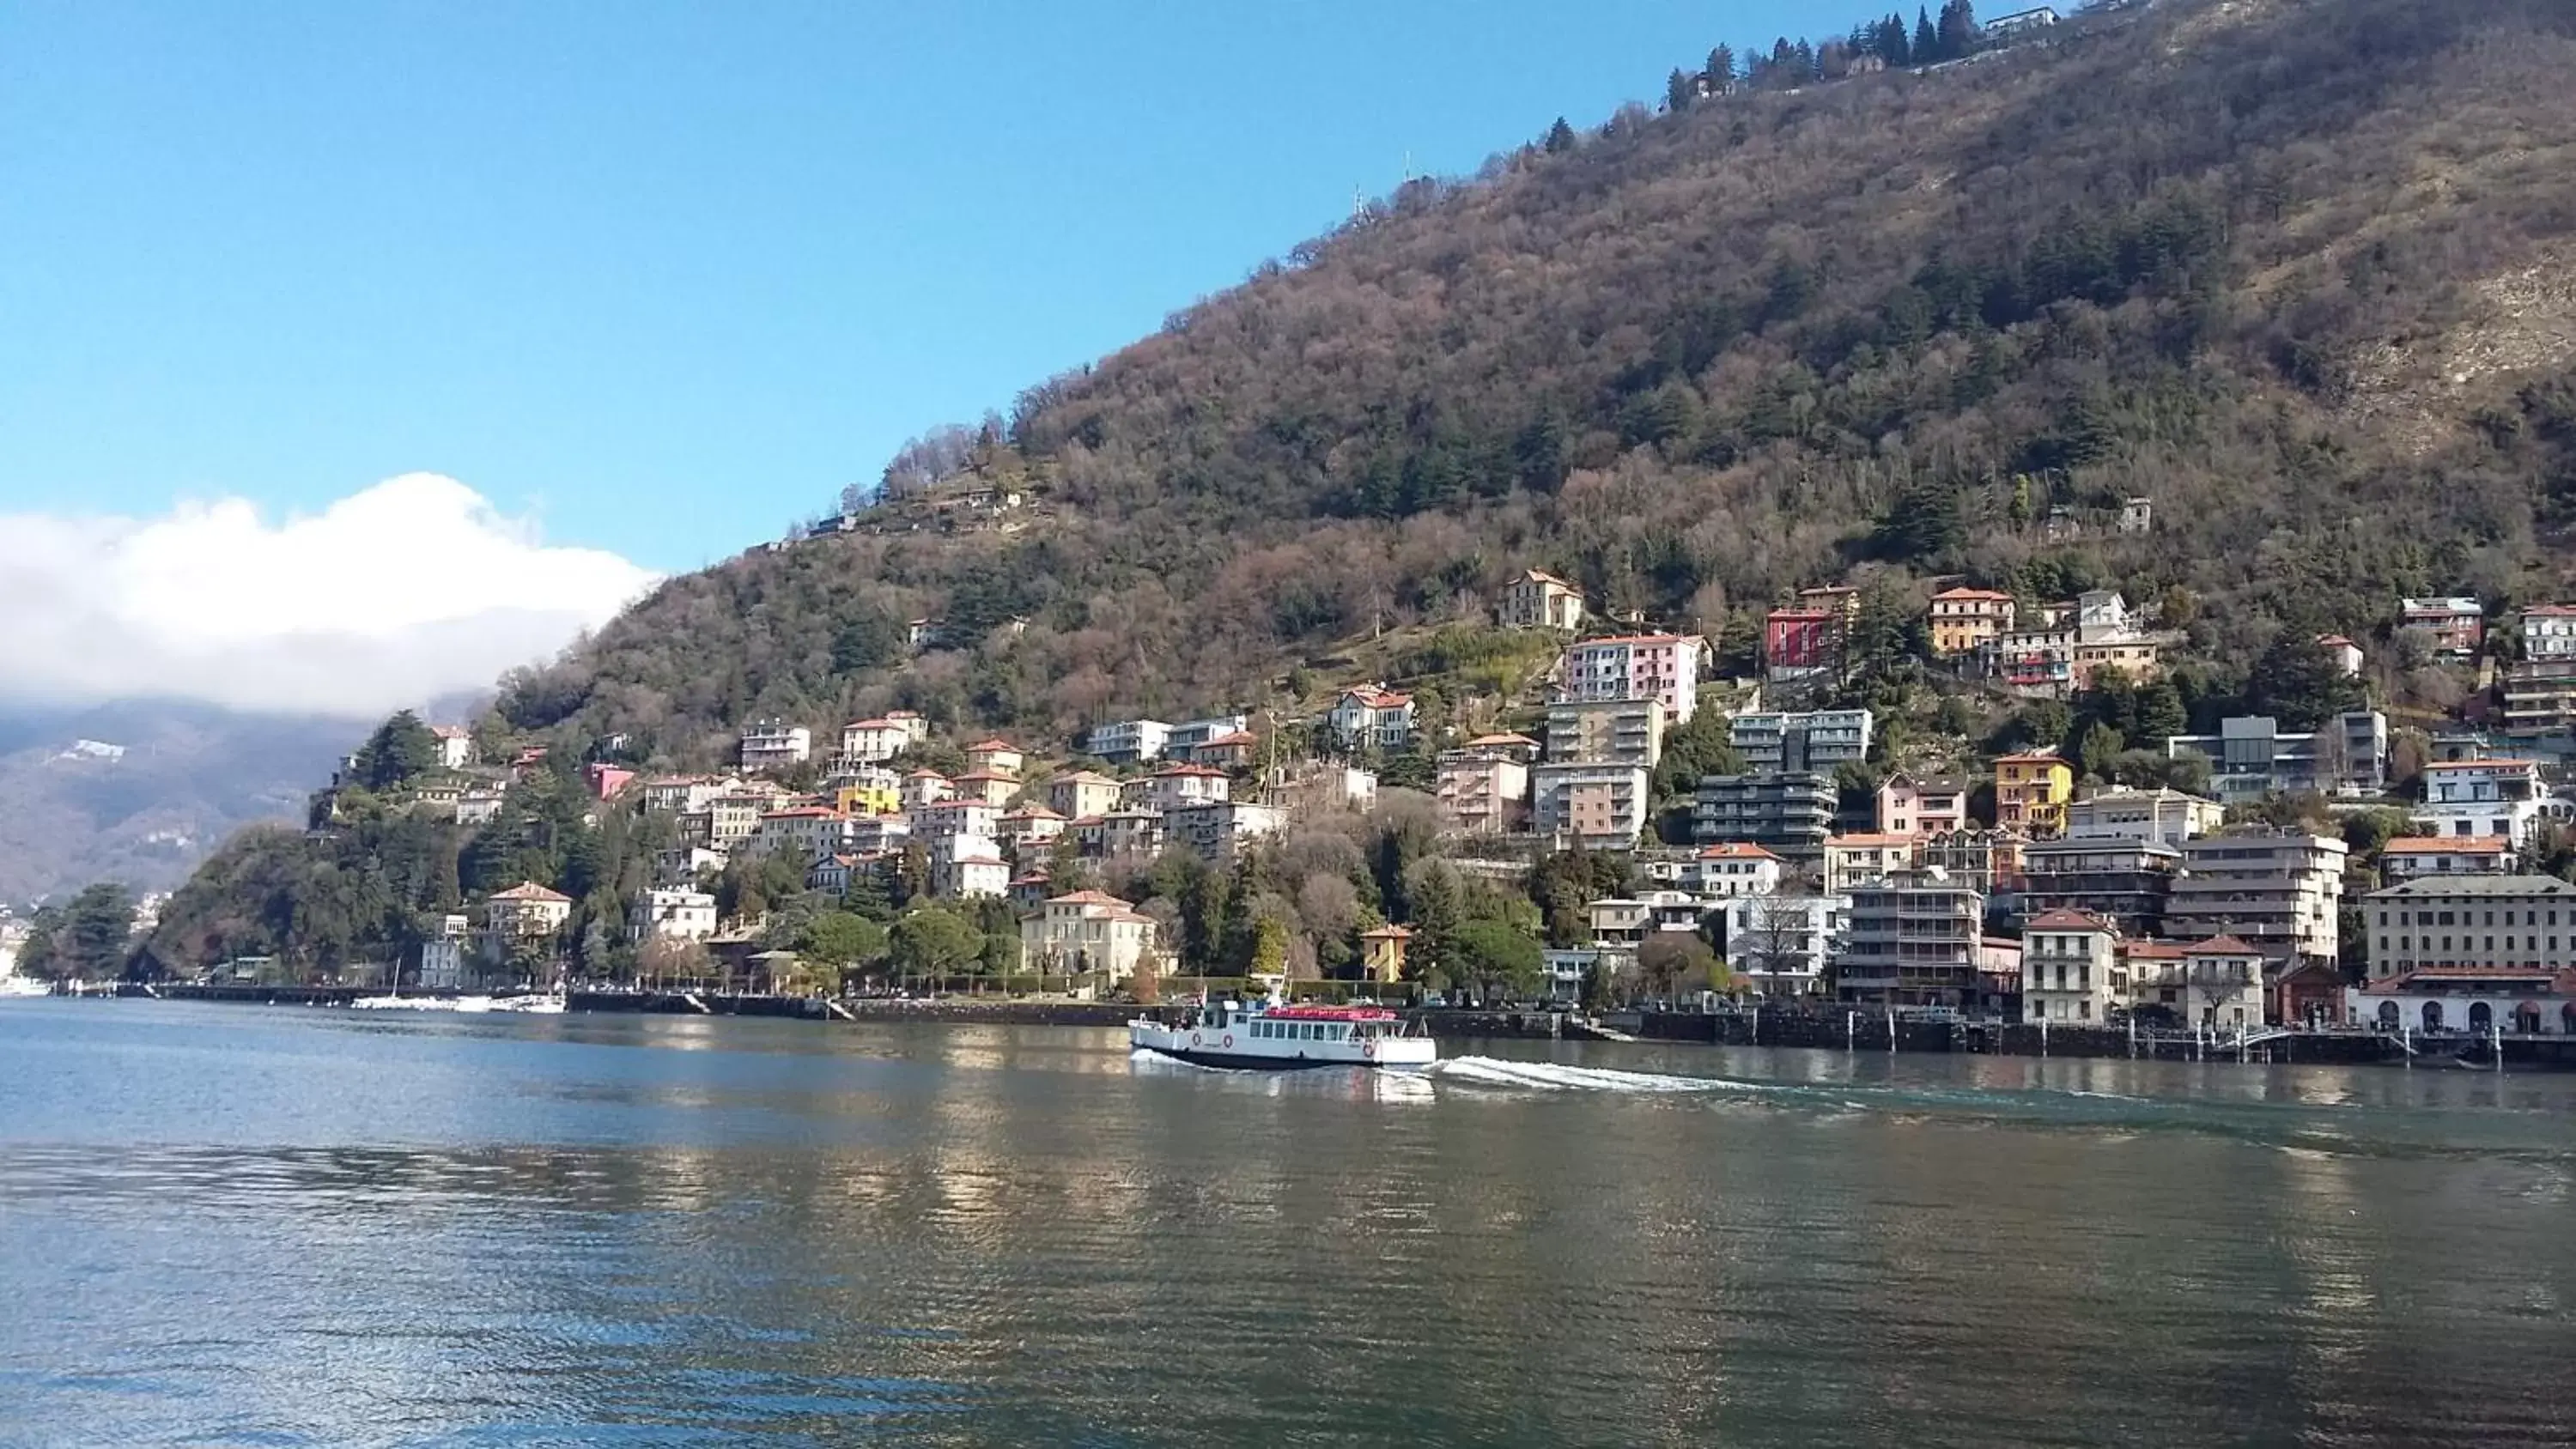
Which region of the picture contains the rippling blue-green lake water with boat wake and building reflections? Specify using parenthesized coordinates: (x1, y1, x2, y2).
(0, 1001, 2576, 1449)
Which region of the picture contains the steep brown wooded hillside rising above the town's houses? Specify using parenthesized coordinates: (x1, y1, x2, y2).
(487, 0, 2576, 761)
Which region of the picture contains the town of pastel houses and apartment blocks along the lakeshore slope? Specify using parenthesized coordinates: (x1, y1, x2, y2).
(111, 558, 2576, 1055)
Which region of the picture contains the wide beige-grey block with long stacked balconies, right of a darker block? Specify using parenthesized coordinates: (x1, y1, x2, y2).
(2164, 831, 2349, 965)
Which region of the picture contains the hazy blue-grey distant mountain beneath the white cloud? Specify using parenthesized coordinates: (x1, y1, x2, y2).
(0, 700, 368, 906)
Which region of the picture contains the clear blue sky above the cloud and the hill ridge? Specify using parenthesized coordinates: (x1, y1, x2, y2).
(0, 0, 1824, 569)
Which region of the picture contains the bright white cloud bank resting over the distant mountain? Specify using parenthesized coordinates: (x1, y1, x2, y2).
(0, 474, 654, 716)
